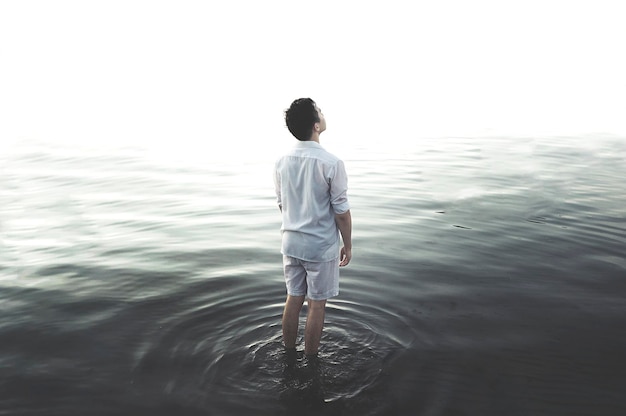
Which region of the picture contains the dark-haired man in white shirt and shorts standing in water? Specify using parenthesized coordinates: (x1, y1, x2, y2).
(274, 98, 352, 358)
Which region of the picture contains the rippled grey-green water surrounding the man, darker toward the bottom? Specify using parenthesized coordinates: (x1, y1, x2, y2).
(0, 137, 626, 415)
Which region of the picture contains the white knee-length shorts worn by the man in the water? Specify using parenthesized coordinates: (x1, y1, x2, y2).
(283, 256, 339, 300)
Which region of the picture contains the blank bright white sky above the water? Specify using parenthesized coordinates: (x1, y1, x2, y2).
(0, 0, 626, 153)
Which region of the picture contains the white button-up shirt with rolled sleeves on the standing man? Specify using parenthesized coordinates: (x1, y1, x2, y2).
(274, 141, 350, 262)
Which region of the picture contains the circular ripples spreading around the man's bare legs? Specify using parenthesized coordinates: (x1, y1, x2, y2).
(129, 276, 412, 411)
